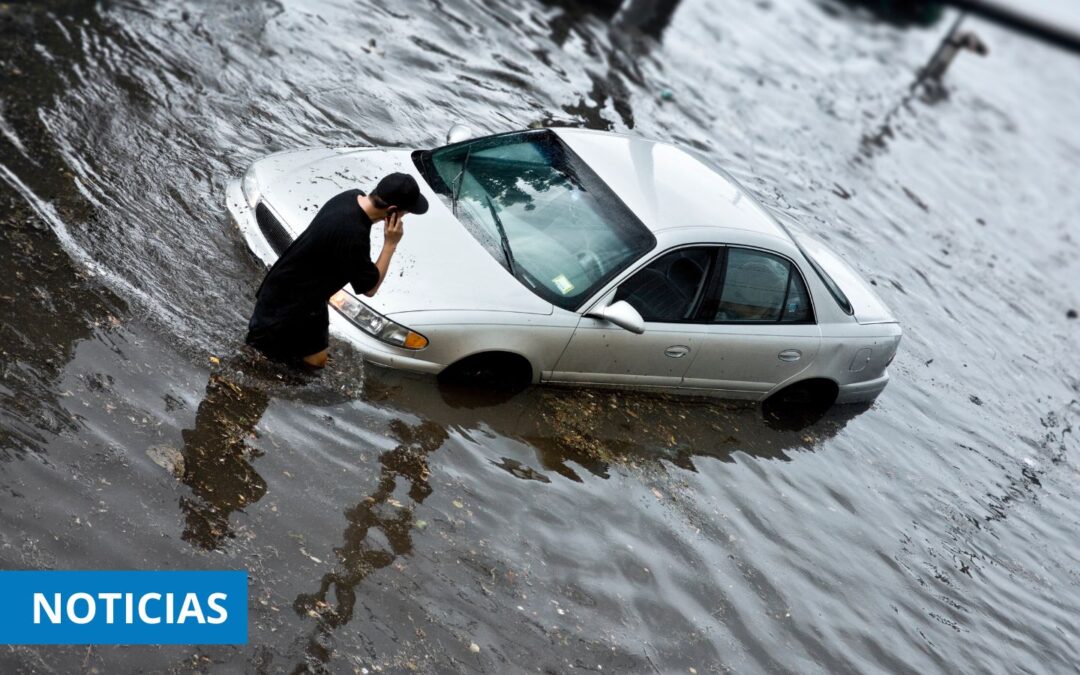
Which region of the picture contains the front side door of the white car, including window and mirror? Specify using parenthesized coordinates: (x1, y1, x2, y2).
(552, 246, 717, 389)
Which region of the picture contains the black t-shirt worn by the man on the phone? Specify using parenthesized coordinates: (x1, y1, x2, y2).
(252, 190, 379, 326)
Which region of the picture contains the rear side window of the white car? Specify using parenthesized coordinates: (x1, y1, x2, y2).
(713, 247, 811, 323)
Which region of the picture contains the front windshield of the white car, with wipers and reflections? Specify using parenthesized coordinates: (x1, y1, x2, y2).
(417, 130, 656, 310)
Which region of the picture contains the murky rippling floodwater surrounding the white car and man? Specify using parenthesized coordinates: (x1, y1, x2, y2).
(0, 0, 1080, 673)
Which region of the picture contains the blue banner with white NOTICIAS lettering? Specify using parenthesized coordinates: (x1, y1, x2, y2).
(0, 571, 247, 645)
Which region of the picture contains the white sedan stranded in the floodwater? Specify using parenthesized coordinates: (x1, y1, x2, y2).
(228, 127, 901, 403)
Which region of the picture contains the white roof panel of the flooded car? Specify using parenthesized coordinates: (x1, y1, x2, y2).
(551, 129, 791, 241)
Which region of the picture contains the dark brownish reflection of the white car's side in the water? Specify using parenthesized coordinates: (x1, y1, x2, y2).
(363, 367, 869, 482)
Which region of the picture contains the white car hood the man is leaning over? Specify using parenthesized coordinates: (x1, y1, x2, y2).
(254, 148, 552, 315)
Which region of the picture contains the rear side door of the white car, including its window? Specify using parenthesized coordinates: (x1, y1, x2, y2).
(683, 246, 821, 400)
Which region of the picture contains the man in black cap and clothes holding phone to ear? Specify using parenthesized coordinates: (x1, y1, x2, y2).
(247, 174, 428, 368)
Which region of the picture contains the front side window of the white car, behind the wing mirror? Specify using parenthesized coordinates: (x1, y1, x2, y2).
(615, 247, 714, 323)
